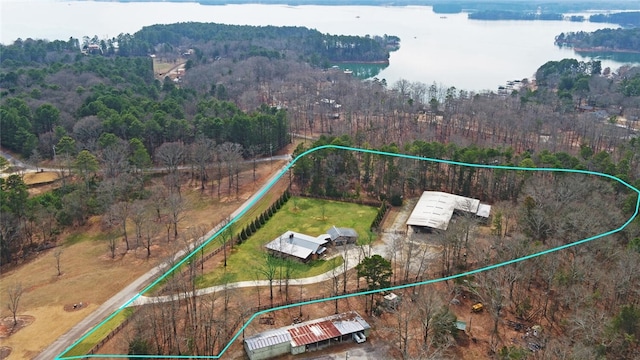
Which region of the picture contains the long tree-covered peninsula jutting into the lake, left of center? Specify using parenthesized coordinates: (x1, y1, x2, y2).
(117, 23, 400, 65)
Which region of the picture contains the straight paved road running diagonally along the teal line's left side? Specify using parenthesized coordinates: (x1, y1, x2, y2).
(34, 156, 290, 360)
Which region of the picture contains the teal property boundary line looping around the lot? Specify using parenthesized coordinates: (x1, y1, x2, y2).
(55, 145, 640, 360)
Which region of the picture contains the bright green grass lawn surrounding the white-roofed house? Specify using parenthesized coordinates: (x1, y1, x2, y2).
(192, 197, 377, 287)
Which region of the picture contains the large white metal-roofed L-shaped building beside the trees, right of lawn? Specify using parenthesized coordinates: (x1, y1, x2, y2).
(407, 191, 491, 230)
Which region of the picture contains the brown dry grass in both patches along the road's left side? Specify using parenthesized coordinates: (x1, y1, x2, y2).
(0, 156, 290, 359)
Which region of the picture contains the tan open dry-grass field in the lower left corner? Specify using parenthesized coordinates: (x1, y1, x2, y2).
(0, 235, 152, 359)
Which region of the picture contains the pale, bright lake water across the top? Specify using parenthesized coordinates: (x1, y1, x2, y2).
(0, 0, 640, 91)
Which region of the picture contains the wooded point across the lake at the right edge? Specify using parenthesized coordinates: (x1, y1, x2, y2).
(555, 27, 640, 53)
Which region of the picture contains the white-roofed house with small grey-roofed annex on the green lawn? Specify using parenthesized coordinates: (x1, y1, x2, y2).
(265, 226, 358, 262)
